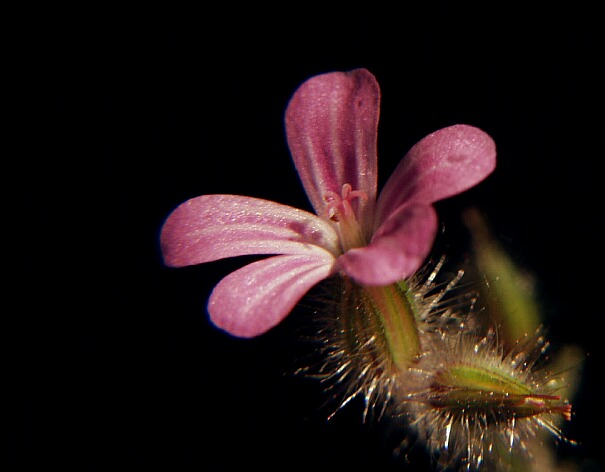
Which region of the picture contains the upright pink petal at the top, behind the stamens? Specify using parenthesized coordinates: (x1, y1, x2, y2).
(286, 69, 380, 227)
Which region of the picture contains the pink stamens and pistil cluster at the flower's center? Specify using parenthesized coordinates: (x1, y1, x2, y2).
(324, 184, 368, 252)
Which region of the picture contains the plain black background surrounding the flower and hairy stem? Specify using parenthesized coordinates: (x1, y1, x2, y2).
(14, 2, 605, 472)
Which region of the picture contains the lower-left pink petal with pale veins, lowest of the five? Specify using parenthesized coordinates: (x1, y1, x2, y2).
(208, 254, 334, 338)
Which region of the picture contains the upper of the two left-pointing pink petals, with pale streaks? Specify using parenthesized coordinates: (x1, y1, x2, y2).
(160, 195, 340, 267)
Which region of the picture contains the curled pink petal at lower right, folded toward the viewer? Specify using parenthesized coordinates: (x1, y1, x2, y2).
(337, 205, 437, 285)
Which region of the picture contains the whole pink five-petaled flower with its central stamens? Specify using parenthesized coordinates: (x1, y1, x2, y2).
(160, 69, 496, 337)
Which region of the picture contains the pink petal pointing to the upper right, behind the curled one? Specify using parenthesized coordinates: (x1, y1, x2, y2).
(375, 125, 496, 225)
